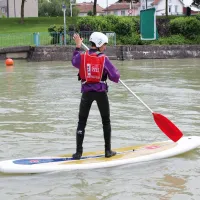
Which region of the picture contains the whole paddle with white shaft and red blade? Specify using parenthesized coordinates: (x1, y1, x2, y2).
(82, 43, 183, 142)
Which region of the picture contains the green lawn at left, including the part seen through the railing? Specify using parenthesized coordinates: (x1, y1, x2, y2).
(0, 17, 77, 47)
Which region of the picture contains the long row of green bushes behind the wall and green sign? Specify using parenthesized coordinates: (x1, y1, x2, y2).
(48, 15, 200, 45)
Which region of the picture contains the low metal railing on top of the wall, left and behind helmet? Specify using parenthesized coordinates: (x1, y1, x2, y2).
(0, 31, 116, 48)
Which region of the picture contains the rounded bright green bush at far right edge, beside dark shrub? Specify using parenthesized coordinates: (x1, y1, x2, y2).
(170, 17, 200, 39)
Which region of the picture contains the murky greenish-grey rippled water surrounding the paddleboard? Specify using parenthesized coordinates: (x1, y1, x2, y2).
(0, 59, 200, 200)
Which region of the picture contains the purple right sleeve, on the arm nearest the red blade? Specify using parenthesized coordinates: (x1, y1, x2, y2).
(104, 57, 120, 83)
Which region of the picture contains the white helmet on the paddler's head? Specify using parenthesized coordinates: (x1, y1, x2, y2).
(89, 32, 108, 47)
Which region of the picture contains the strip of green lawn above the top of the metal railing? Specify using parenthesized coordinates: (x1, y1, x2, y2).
(0, 17, 77, 34)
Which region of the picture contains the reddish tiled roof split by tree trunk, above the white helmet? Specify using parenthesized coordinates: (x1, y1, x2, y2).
(76, 1, 104, 13)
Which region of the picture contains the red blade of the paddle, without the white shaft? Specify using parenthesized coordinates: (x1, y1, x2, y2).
(152, 113, 183, 142)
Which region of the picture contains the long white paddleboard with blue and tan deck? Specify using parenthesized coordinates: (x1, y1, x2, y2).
(0, 136, 200, 174)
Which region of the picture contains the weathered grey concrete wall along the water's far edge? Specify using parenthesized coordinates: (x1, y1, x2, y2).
(0, 45, 200, 62)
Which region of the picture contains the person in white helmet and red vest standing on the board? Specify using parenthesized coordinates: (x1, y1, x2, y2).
(72, 32, 120, 159)
